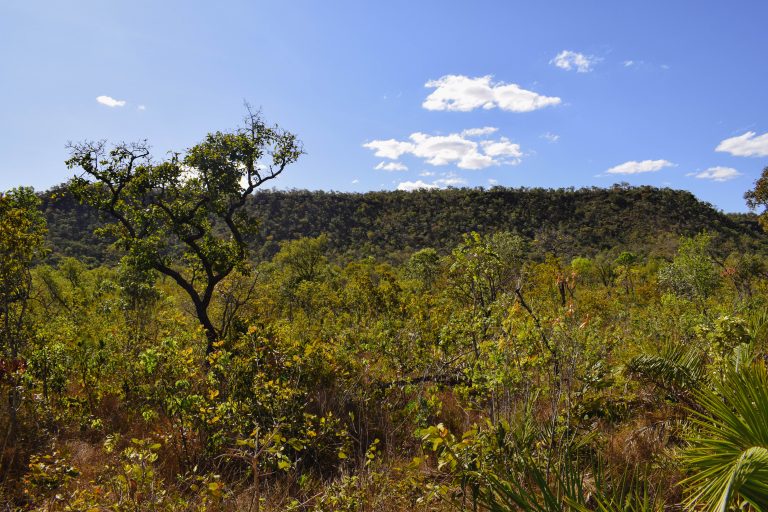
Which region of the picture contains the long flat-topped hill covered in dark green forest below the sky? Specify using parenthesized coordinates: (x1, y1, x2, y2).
(43, 185, 768, 263)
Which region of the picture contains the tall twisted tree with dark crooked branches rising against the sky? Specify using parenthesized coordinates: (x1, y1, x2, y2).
(67, 108, 303, 353)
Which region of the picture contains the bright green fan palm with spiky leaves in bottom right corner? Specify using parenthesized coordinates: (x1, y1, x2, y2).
(682, 363, 768, 512)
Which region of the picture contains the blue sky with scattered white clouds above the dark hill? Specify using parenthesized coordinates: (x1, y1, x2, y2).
(0, 0, 768, 211)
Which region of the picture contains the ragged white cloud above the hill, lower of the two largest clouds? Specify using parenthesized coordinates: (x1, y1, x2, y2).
(363, 132, 523, 170)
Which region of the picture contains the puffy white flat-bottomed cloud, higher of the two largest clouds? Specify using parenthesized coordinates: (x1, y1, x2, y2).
(422, 75, 561, 112)
